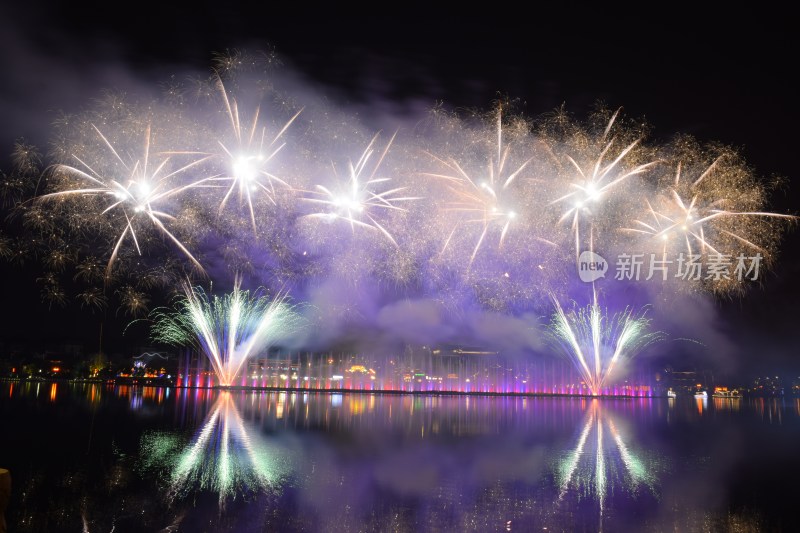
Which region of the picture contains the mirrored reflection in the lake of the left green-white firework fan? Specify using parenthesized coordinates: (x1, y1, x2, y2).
(140, 392, 288, 508)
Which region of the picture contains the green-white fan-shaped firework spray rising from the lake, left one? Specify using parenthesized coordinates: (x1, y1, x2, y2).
(153, 278, 300, 386)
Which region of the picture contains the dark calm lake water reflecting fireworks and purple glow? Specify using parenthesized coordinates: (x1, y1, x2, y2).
(0, 382, 800, 533)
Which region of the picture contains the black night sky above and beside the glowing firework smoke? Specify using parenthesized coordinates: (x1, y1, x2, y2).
(0, 2, 800, 374)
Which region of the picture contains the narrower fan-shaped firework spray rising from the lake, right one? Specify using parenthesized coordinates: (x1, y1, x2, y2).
(549, 289, 662, 396)
